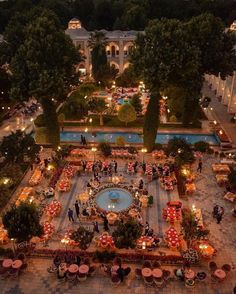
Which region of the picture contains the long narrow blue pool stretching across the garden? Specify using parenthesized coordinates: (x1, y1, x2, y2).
(60, 131, 220, 145)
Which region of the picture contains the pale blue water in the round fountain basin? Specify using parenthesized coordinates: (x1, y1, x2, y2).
(96, 188, 133, 212)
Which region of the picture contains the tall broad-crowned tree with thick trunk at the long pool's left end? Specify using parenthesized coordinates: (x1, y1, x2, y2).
(11, 13, 80, 148)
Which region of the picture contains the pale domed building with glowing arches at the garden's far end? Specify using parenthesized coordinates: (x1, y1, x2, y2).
(66, 18, 141, 74)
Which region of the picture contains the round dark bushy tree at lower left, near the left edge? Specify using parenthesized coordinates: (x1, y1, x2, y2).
(2, 202, 43, 242)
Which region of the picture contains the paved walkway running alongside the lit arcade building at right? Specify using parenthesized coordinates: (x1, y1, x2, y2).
(202, 83, 236, 146)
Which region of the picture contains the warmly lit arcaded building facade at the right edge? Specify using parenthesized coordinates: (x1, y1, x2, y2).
(205, 21, 236, 114)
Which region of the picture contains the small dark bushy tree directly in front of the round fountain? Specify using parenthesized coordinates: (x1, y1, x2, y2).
(112, 219, 142, 249)
